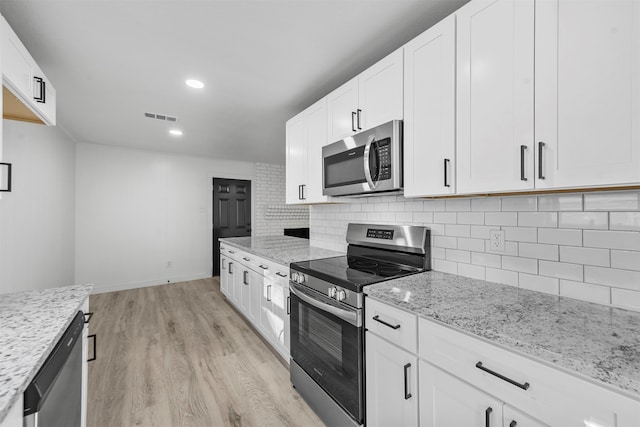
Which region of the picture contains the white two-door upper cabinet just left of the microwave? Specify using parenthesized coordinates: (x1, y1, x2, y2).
(286, 98, 328, 204)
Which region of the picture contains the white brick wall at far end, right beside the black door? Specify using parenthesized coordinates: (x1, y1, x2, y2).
(252, 163, 309, 236)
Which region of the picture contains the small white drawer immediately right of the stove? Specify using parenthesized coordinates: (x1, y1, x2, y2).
(364, 298, 418, 354)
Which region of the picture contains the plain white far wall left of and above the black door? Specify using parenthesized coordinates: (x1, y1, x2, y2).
(75, 143, 254, 292)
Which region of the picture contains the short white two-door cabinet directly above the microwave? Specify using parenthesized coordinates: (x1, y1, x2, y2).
(326, 48, 403, 143)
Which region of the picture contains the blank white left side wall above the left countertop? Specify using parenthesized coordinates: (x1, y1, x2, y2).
(0, 120, 75, 293)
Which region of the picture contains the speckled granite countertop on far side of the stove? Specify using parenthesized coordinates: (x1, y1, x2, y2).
(220, 236, 344, 265)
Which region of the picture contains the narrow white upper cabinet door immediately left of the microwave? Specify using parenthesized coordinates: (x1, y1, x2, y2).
(303, 98, 327, 203)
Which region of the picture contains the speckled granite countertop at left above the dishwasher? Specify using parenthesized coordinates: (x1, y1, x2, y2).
(0, 285, 93, 423)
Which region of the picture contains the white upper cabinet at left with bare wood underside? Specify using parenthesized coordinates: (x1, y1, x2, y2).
(0, 17, 56, 126)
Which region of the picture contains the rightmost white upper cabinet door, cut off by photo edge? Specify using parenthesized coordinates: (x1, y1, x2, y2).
(535, 0, 640, 188)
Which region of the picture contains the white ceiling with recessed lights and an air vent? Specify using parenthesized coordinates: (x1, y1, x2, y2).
(0, 0, 468, 164)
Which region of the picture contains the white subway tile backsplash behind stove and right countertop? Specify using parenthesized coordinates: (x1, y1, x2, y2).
(310, 191, 640, 311)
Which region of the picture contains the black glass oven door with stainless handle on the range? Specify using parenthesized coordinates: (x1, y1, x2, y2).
(289, 282, 364, 423)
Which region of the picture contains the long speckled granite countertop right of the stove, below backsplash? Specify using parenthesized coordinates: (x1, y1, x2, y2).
(365, 271, 640, 399)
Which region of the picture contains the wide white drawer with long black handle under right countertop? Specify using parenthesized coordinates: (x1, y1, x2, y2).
(418, 319, 640, 427)
